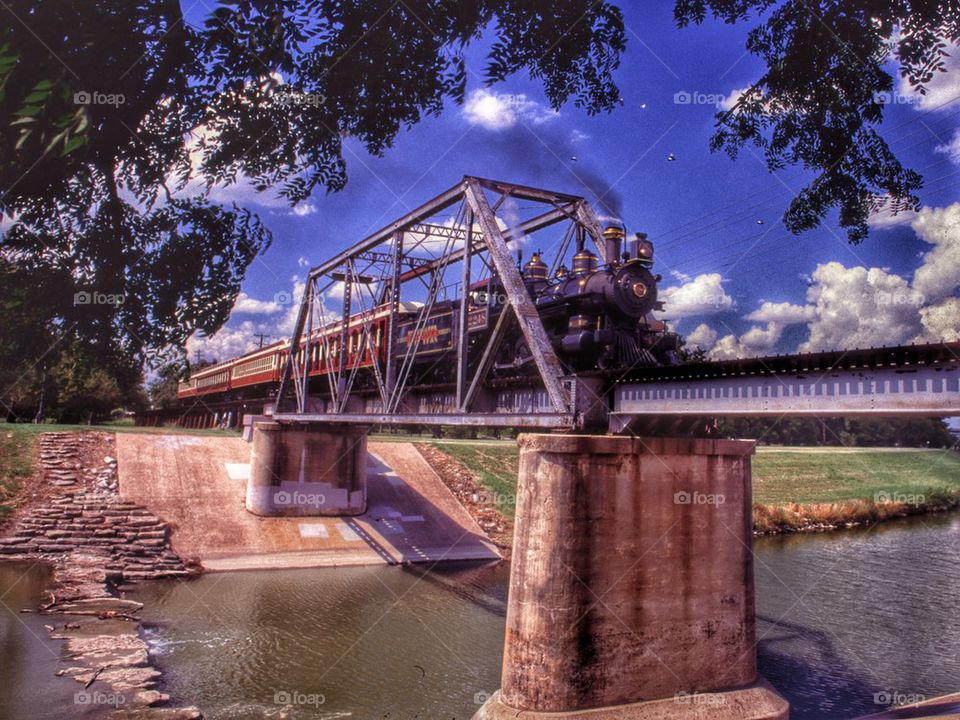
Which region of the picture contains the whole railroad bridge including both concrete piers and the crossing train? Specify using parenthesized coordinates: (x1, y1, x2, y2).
(169, 177, 960, 720)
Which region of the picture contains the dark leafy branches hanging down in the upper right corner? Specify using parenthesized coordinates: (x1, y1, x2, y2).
(674, 0, 960, 242)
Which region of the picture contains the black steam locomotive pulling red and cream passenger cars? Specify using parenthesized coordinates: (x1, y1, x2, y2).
(178, 226, 678, 414)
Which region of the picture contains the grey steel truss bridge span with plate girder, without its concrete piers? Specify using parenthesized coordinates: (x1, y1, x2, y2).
(274, 176, 960, 432)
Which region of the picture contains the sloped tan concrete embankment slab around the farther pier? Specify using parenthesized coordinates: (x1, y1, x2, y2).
(117, 433, 500, 570)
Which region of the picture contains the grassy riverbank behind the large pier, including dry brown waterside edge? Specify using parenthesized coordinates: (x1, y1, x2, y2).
(431, 441, 960, 532)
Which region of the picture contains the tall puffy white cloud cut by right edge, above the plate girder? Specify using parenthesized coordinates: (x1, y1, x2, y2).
(912, 202, 960, 302)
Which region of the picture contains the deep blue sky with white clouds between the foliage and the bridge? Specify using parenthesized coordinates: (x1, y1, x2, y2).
(190, 2, 960, 366)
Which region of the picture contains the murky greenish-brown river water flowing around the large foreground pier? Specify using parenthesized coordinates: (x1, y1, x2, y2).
(0, 513, 960, 720)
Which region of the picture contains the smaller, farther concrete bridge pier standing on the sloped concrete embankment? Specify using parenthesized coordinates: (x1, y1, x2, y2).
(246, 422, 368, 516)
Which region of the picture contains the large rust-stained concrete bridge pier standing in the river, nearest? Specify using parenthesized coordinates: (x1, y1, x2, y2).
(474, 435, 789, 720)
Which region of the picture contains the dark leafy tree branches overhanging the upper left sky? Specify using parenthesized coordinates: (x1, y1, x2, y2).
(0, 0, 624, 388)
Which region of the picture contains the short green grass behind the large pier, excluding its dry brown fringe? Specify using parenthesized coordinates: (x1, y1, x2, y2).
(428, 440, 960, 517)
